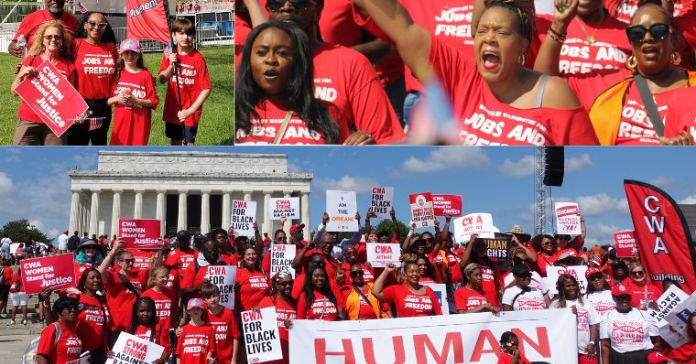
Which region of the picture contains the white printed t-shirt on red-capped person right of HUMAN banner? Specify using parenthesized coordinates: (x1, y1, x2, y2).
(599, 308, 660, 353)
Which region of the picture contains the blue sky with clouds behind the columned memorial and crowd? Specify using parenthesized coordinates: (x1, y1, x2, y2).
(0, 147, 696, 245)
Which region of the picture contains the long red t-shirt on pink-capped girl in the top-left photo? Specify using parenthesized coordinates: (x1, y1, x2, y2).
(109, 69, 159, 145)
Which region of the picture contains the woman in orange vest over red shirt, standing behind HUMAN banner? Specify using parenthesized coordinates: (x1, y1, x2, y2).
(342, 262, 389, 320)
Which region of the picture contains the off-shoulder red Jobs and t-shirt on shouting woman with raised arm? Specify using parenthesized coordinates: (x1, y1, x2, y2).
(430, 38, 598, 145)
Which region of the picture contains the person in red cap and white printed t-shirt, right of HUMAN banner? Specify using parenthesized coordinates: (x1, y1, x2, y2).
(599, 284, 661, 364)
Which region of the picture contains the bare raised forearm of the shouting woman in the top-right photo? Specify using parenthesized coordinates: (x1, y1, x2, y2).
(354, 0, 432, 78)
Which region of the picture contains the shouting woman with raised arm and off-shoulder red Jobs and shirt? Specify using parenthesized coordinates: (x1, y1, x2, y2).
(358, 0, 597, 145)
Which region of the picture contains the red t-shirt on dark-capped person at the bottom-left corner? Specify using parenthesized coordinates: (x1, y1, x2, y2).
(36, 321, 83, 364)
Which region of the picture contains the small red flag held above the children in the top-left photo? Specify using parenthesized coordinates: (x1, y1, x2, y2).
(126, 0, 171, 44)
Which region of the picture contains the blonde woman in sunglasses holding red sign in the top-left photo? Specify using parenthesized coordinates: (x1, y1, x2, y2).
(11, 20, 75, 145)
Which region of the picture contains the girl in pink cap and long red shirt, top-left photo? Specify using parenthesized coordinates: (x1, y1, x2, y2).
(108, 39, 159, 145)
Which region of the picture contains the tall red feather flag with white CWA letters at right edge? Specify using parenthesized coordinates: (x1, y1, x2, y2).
(624, 180, 696, 292)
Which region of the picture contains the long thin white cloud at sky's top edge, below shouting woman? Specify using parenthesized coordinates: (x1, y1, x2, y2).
(401, 147, 490, 173)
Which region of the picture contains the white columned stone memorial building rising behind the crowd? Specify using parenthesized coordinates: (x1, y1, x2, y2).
(68, 151, 313, 240)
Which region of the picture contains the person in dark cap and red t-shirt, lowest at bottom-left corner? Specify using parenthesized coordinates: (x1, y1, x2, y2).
(36, 296, 84, 364)
